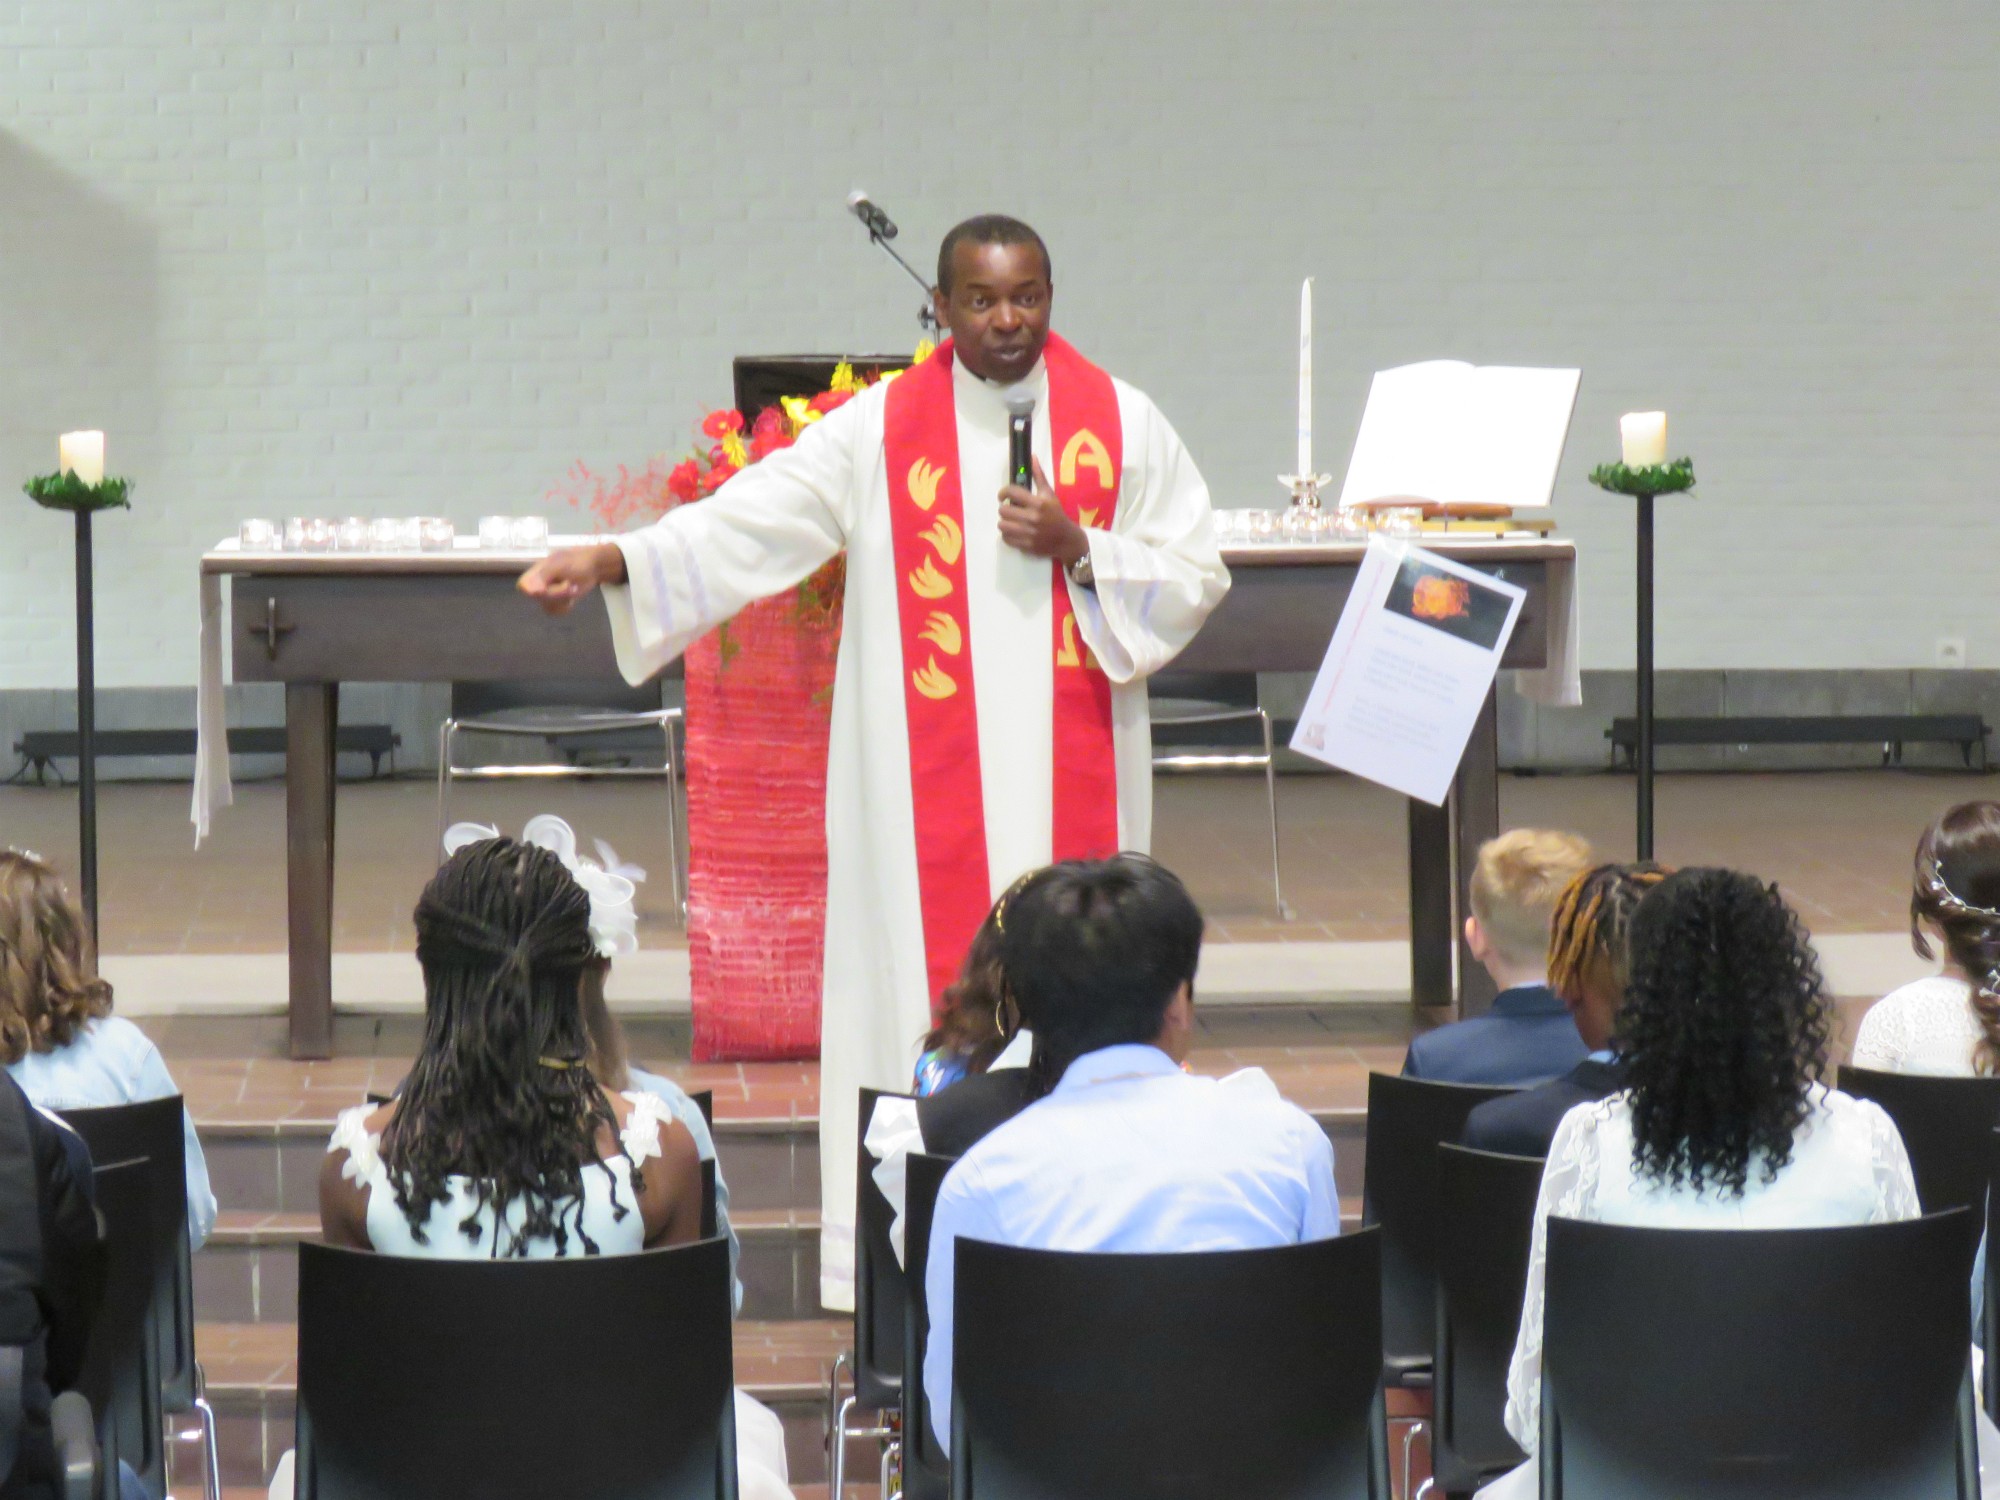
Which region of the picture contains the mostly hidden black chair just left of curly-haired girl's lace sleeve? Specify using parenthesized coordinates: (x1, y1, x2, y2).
(1432, 1144, 1542, 1496)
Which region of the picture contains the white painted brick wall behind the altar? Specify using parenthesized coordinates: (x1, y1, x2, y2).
(0, 0, 2000, 686)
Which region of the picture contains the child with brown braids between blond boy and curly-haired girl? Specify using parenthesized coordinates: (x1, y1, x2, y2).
(1460, 862, 1670, 1156)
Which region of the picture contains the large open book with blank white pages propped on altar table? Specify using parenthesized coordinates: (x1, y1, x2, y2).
(1340, 360, 1582, 510)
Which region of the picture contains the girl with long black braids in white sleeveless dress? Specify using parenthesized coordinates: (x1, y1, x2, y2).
(308, 838, 792, 1500)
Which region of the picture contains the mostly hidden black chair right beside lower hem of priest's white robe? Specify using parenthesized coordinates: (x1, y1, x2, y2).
(826, 1088, 910, 1496)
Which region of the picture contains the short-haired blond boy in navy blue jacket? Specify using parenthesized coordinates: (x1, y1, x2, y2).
(1402, 828, 1592, 1084)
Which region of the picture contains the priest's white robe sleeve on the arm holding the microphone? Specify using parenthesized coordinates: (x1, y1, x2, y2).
(1070, 402, 1230, 682)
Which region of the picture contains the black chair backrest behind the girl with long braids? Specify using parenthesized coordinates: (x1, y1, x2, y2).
(296, 1240, 736, 1500)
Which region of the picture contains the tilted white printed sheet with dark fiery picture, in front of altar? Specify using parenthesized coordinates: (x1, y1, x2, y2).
(1292, 536, 1526, 806)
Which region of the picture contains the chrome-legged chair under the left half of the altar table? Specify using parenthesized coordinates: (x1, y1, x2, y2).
(438, 680, 688, 922)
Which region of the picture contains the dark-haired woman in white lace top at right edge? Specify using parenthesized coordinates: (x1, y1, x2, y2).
(1854, 802, 2000, 1076)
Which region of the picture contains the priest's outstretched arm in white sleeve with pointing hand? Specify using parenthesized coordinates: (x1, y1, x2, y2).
(520, 412, 858, 682)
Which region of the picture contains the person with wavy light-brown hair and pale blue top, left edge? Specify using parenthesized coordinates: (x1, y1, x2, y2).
(0, 848, 216, 1250)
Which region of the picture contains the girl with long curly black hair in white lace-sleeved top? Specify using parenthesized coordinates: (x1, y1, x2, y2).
(1480, 870, 1922, 1500)
